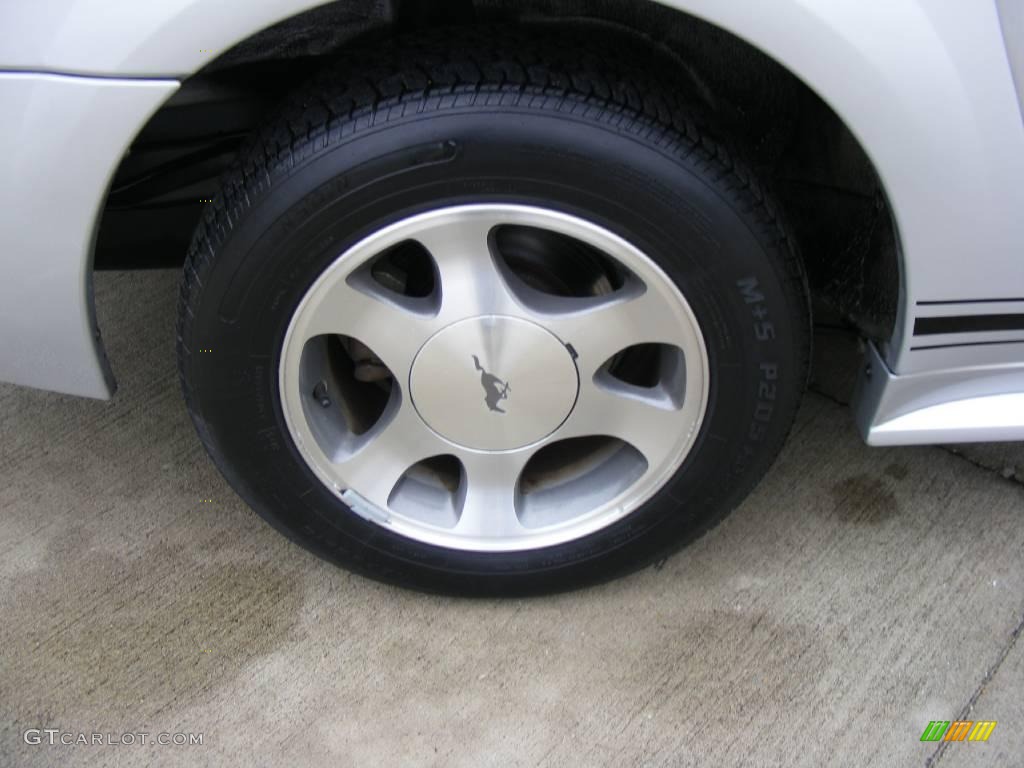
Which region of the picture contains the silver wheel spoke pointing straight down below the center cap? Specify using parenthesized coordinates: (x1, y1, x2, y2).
(455, 451, 531, 539)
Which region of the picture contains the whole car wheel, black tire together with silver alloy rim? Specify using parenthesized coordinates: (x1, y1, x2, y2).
(178, 31, 809, 594)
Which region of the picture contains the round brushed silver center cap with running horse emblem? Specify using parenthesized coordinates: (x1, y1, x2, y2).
(410, 315, 580, 451)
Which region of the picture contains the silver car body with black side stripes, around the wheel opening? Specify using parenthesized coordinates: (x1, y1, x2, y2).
(0, 0, 1024, 444)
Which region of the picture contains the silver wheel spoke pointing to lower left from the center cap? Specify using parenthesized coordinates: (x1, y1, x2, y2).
(334, 401, 444, 509)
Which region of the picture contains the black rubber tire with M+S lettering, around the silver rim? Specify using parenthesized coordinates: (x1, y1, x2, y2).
(178, 31, 810, 594)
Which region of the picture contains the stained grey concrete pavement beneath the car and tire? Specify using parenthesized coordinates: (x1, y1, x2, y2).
(0, 272, 1024, 768)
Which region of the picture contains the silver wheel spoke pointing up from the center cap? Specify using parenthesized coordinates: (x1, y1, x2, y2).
(416, 217, 520, 322)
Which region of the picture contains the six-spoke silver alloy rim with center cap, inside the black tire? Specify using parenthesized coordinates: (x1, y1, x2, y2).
(279, 204, 709, 552)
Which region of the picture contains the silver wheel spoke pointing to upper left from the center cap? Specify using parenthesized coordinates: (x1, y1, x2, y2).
(304, 280, 438, 382)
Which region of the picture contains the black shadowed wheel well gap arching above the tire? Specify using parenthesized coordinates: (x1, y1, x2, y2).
(95, 0, 900, 339)
